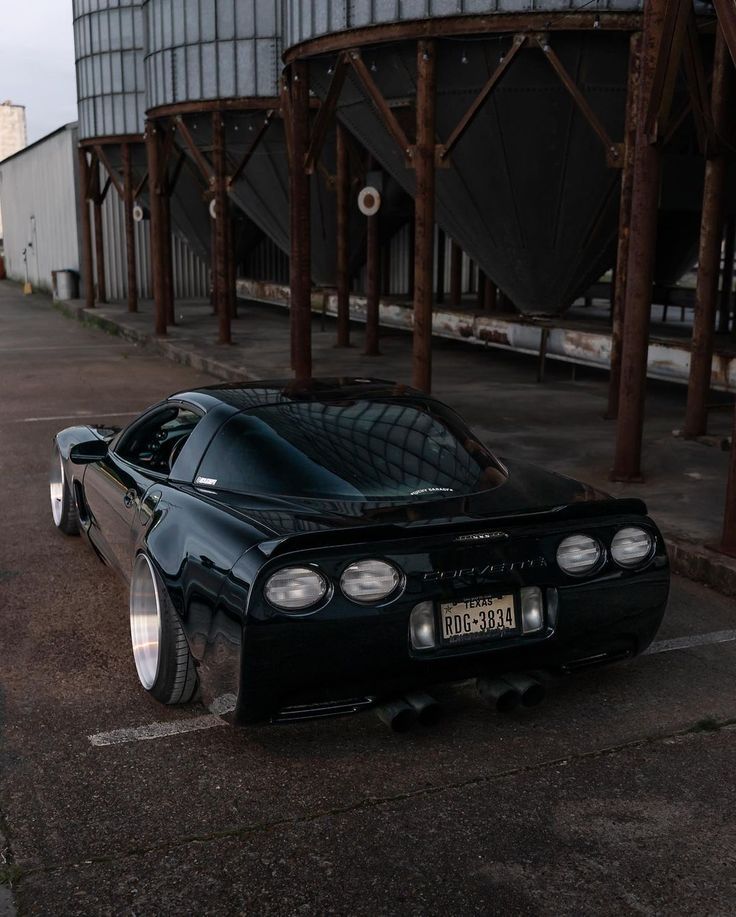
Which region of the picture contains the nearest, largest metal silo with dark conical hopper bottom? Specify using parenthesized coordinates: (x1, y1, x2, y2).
(285, 0, 702, 313)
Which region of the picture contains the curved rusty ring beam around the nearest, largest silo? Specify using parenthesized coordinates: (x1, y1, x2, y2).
(284, 10, 642, 64)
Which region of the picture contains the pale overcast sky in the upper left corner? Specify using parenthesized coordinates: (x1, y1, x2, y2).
(0, 0, 77, 143)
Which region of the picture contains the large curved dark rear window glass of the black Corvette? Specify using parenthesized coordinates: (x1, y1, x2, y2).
(195, 401, 505, 501)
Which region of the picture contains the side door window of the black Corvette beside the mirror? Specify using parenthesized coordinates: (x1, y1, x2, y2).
(116, 405, 201, 474)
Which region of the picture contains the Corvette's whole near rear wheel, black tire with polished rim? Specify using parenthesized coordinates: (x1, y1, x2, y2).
(130, 554, 197, 704)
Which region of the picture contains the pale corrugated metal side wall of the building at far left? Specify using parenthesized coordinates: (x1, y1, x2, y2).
(0, 124, 79, 289)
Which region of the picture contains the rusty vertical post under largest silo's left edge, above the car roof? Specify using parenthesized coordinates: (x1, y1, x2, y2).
(289, 61, 312, 379)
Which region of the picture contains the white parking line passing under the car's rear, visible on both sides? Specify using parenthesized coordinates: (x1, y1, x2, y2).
(88, 630, 736, 746)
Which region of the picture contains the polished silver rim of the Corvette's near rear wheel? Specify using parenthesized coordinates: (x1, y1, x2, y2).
(130, 554, 161, 691)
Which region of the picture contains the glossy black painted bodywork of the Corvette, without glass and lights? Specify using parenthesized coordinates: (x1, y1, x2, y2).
(56, 380, 669, 723)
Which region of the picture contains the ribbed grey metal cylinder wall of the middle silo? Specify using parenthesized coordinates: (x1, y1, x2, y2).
(144, 0, 282, 108)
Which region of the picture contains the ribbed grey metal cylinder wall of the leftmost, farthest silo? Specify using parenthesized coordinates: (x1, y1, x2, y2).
(74, 0, 145, 139)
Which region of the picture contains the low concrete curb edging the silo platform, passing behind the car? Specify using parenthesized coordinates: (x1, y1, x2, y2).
(54, 300, 736, 596)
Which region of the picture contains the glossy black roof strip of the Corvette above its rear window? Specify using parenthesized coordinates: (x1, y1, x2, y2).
(170, 377, 431, 411)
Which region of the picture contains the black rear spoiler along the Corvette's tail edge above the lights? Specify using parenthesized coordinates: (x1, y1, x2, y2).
(259, 498, 647, 557)
